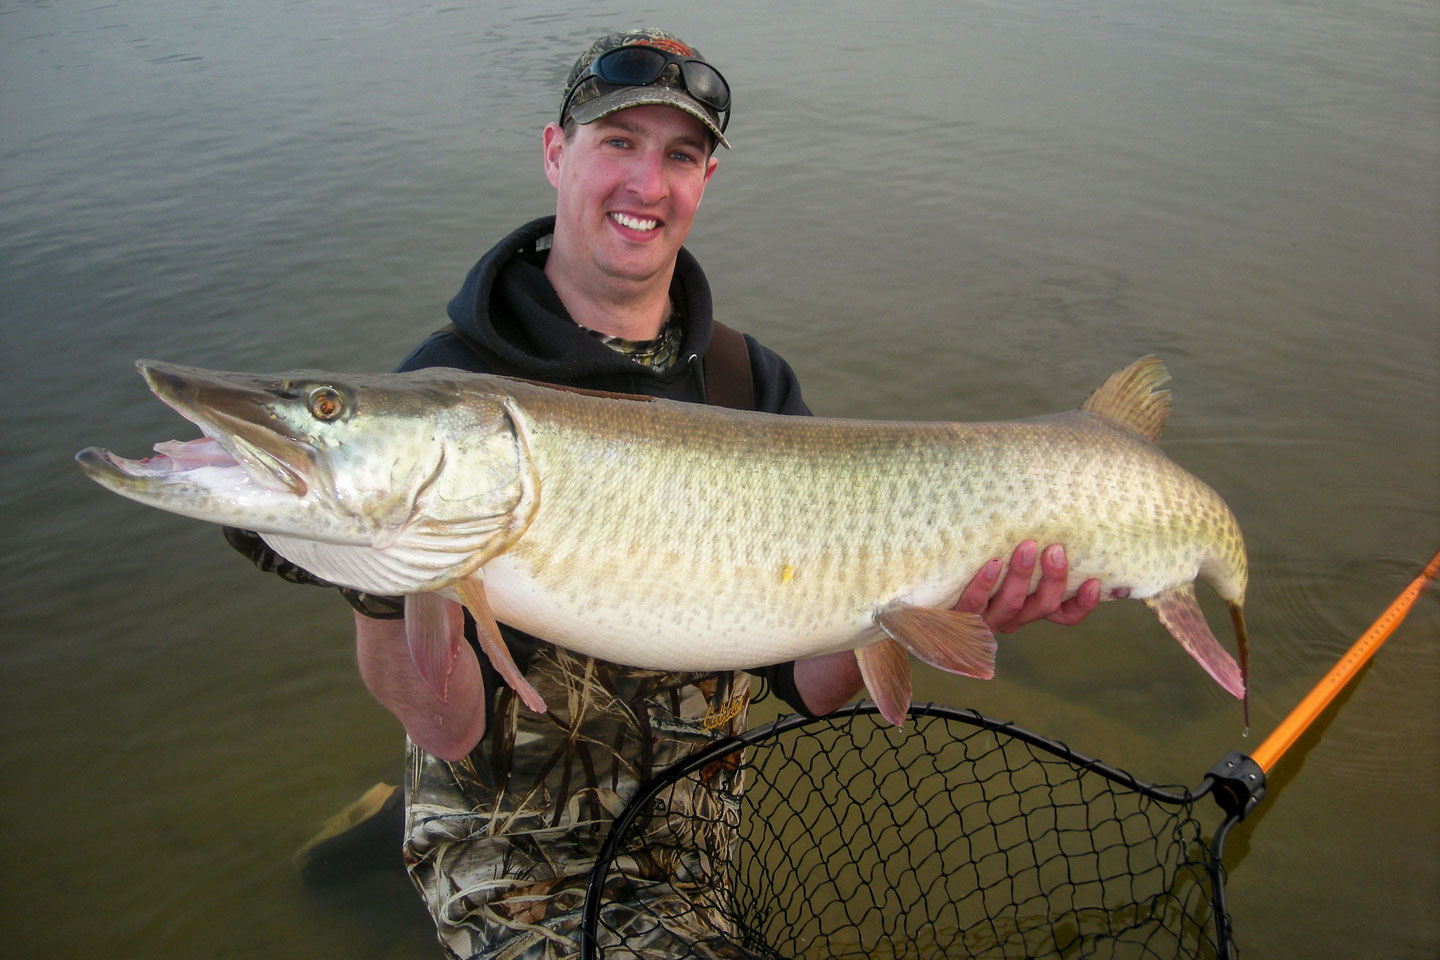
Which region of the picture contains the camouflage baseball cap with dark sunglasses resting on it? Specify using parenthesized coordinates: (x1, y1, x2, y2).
(560, 27, 730, 150)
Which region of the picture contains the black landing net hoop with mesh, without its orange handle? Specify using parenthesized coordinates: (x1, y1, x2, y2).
(580, 704, 1241, 960)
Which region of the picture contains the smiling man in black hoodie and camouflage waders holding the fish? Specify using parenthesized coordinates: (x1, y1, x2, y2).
(250, 29, 1099, 957)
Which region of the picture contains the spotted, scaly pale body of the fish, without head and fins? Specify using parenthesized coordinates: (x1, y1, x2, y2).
(485, 384, 1234, 669)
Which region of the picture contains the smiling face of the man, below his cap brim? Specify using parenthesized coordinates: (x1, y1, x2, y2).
(544, 105, 716, 291)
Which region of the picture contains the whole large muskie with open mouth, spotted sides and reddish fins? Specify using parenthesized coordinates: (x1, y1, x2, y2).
(76, 357, 1247, 724)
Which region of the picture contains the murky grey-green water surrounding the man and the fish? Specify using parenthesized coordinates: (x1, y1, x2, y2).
(0, 0, 1440, 957)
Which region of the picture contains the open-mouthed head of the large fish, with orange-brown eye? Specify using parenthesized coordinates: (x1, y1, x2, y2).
(76, 360, 534, 576)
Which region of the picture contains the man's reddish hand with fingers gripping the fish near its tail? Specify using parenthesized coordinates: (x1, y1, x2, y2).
(955, 540, 1100, 633)
